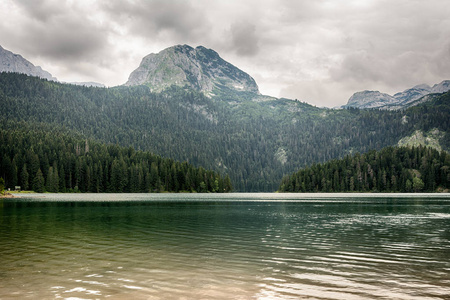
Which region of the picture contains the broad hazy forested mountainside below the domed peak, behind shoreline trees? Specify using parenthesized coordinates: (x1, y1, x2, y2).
(0, 73, 450, 192)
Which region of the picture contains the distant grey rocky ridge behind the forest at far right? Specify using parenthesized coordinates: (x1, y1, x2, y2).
(342, 80, 450, 110)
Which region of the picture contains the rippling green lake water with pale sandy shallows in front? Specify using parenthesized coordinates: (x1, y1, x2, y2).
(0, 194, 450, 299)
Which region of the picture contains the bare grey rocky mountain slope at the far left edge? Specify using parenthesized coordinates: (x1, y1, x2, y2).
(0, 46, 57, 81)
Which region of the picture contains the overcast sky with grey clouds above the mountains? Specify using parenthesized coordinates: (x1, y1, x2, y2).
(0, 0, 450, 107)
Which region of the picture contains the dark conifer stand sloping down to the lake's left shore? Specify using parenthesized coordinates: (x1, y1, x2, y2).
(0, 123, 232, 193)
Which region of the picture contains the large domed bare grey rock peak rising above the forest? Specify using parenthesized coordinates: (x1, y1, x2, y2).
(125, 45, 259, 95)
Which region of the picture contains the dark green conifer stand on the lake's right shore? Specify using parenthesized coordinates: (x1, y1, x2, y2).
(279, 146, 450, 192)
